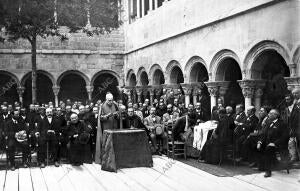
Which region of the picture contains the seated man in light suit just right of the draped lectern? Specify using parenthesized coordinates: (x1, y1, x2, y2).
(144, 107, 168, 154)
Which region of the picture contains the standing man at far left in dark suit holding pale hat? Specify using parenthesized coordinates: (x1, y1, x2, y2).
(5, 110, 29, 170)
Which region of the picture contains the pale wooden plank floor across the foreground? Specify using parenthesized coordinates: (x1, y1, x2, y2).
(0, 156, 300, 191)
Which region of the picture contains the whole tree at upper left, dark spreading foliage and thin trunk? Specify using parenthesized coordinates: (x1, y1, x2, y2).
(0, 0, 121, 103)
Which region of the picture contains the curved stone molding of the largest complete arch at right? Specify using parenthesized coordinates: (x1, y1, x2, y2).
(243, 40, 292, 79)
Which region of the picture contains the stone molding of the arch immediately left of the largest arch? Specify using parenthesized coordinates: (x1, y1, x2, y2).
(209, 49, 241, 81)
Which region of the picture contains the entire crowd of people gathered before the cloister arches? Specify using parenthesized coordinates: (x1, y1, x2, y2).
(0, 89, 300, 177)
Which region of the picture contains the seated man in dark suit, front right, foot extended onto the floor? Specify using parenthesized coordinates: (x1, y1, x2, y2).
(257, 109, 288, 177)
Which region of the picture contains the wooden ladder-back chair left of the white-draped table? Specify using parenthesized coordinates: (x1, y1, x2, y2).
(165, 122, 186, 160)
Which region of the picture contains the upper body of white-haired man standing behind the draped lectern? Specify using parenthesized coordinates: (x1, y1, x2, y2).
(100, 93, 119, 131)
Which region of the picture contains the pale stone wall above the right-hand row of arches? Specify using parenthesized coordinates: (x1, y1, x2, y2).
(125, 0, 300, 83)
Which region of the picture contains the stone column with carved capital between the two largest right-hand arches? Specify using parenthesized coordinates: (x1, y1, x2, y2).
(238, 80, 256, 109)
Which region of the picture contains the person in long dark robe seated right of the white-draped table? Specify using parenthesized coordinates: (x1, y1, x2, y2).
(200, 108, 233, 164)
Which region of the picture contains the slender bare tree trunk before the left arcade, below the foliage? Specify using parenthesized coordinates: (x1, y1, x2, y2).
(31, 36, 37, 104)
